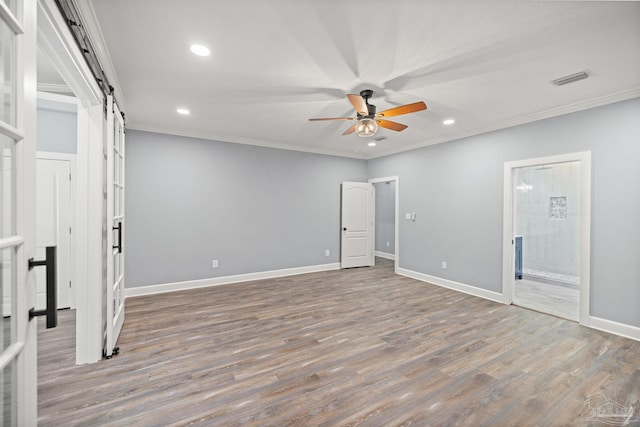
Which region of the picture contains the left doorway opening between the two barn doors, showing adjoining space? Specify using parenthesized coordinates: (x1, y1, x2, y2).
(36, 51, 80, 367)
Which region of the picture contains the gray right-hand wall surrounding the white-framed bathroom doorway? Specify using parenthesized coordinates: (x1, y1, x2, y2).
(368, 98, 640, 327)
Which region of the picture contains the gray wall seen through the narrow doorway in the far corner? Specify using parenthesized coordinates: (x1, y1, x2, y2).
(373, 181, 396, 254)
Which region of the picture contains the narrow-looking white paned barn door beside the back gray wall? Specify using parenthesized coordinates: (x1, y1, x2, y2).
(105, 97, 125, 358)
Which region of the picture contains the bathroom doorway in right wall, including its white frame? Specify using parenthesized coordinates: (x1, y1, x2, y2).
(503, 153, 591, 324)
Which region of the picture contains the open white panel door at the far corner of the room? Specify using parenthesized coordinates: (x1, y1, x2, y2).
(340, 182, 375, 268)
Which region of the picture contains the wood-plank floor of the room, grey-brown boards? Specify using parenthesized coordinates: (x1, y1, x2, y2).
(38, 259, 640, 426)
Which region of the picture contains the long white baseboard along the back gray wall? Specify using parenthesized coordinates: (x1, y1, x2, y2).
(125, 262, 340, 298)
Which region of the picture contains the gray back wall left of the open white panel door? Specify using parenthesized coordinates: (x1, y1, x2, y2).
(125, 130, 367, 287)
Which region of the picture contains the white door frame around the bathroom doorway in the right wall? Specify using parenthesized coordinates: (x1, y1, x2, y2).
(502, 151, 591, 326)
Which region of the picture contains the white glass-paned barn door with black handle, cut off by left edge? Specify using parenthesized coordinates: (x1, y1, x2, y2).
(0, 1, 38, 426)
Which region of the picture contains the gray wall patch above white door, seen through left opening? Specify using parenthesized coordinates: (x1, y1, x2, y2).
(37, 99, 78, 154)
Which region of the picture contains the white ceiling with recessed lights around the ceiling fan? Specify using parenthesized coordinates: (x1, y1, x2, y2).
(80, 0, 640, 158)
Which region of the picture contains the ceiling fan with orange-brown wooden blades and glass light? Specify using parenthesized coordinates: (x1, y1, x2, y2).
(309, 89, 427, 137)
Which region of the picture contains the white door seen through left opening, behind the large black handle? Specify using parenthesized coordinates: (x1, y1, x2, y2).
(35, 158, 71, 309)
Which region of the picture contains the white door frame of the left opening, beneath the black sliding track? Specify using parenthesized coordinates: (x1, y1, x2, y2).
(34, 0, 106, 365)
